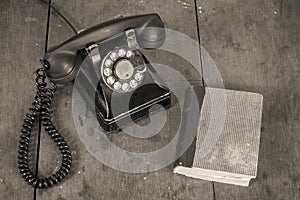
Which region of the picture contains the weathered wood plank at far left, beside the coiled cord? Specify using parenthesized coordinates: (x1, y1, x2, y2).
(0, 0, 47, 199)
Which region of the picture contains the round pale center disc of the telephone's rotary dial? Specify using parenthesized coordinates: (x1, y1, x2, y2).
(115, 59, 134, 80)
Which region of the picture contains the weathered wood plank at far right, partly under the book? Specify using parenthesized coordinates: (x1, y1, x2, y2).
(198, 0, 300, 200)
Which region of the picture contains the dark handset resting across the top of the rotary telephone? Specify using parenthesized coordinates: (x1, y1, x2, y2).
(44, 14, 165, 83)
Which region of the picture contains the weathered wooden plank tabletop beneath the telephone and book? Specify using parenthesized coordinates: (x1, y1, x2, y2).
(0, 0, 300, 200)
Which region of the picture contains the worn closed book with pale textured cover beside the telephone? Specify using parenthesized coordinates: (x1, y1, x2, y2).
(174, 88, 263, 186)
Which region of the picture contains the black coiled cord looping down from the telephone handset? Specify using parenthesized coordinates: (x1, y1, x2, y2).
(18, 61, 72, 189)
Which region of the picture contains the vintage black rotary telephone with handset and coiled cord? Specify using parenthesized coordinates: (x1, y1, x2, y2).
(18, 14, 171, 188)
